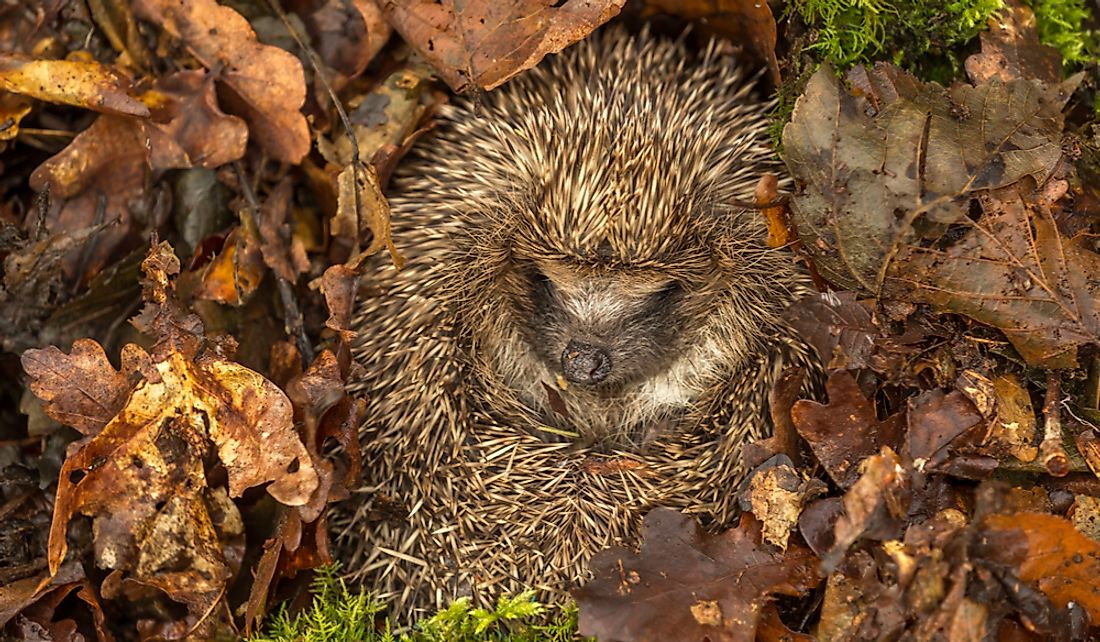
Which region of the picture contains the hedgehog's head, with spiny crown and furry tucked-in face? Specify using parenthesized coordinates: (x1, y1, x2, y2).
(426, 31, 794, 443)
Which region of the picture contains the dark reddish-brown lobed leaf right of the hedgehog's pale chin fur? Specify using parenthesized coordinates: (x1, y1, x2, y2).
(791, 370, 905, 488)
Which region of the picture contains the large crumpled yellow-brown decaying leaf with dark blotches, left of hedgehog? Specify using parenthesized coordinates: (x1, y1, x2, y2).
(23, 239, 318, 615)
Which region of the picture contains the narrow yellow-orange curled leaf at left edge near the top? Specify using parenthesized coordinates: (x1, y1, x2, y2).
(0, 54, 150, 117)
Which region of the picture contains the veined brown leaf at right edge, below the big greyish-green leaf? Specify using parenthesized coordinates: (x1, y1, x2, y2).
(893, 188, 1100, 367)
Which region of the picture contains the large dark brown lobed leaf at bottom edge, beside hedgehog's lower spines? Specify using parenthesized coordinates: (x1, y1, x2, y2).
(573, 508, 821, 642)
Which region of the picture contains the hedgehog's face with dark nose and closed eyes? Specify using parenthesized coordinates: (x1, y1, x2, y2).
(520, 257, 690, 394)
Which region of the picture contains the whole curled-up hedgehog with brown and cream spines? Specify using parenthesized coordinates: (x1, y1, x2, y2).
(334, 30, 810, 616)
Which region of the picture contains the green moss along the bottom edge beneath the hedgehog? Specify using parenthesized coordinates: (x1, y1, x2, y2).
(249, 566, 578, 642)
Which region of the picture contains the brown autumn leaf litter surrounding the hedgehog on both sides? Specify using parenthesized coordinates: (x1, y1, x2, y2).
(0, 0, 1100, 642)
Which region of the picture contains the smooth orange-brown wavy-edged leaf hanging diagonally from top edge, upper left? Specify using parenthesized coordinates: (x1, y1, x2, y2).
(134, 0, 309, 164)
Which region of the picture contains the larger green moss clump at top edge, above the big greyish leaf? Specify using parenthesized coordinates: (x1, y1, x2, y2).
(791, 0, 1007, 70)
